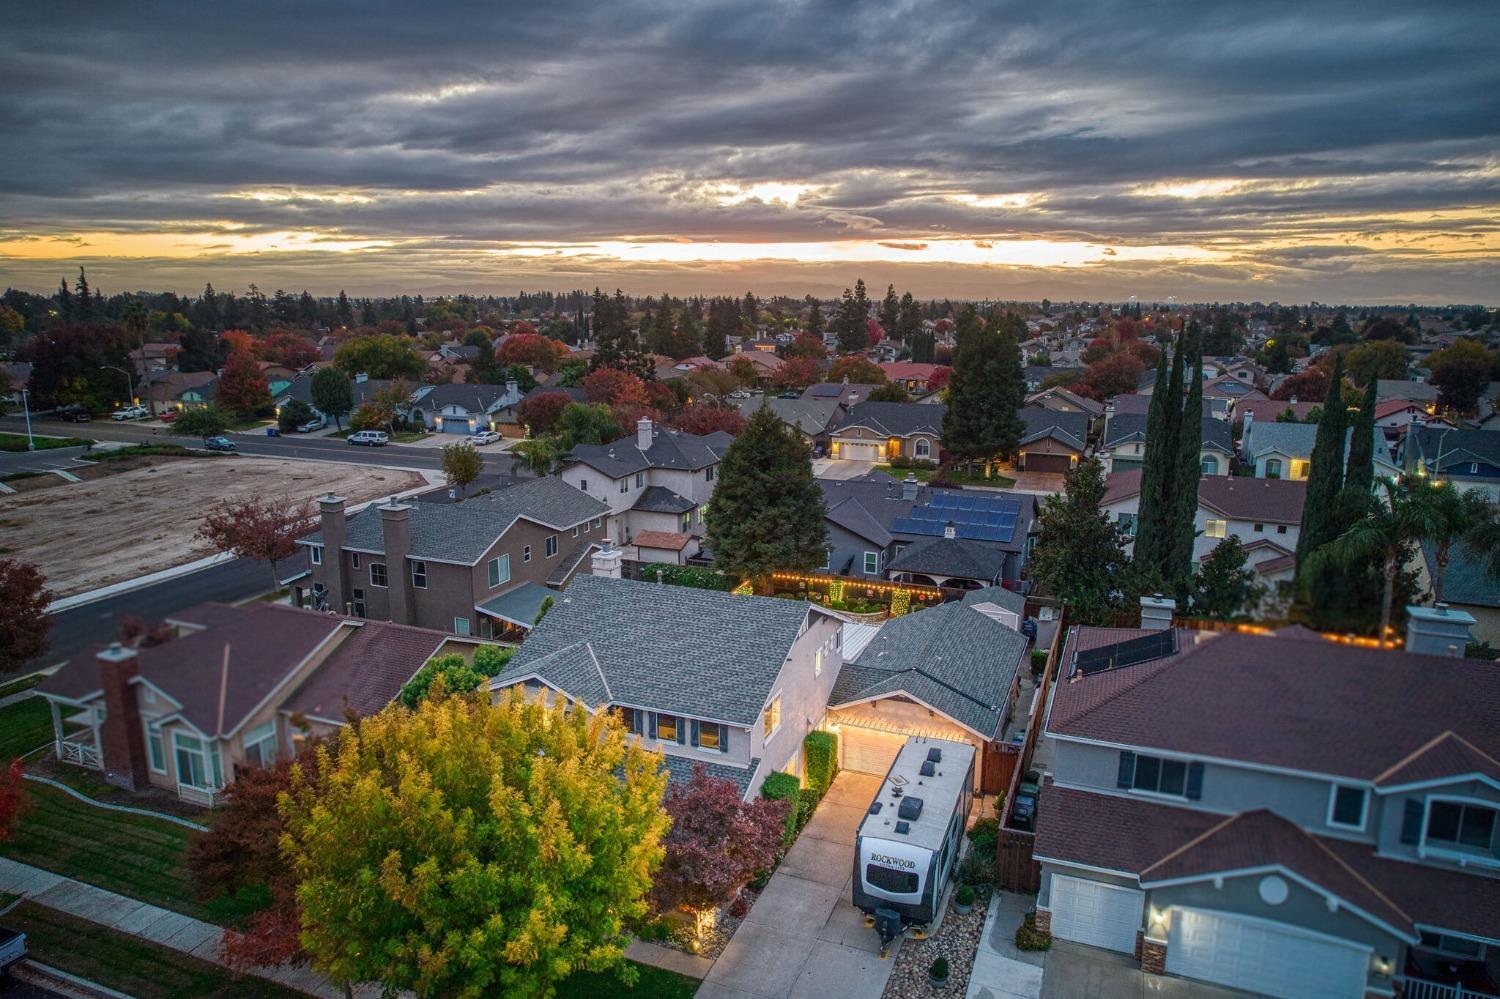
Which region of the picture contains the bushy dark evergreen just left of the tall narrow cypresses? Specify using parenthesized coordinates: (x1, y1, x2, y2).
(1031, 458, 1125, 626)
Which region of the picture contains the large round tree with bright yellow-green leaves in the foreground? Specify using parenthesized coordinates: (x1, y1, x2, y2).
(281, 690, 668, 996)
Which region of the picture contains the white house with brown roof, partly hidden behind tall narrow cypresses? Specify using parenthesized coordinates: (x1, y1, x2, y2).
(1100, 468, 1308, 582)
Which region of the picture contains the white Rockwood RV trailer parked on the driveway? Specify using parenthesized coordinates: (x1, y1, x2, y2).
(854, 737, 974, 954)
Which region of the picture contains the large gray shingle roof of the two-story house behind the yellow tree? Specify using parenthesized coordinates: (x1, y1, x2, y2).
(495, 576, 813, 725)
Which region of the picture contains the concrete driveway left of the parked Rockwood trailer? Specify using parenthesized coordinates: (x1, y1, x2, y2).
(698, 773, 902, 999)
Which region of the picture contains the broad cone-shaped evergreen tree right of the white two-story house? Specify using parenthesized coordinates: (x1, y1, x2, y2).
(707, 405, 828, 581)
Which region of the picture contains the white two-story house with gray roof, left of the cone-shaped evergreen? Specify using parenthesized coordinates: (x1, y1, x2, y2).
(561, 419, 734, 561)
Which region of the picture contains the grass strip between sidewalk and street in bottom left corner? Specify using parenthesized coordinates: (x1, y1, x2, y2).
(5, 902, 303, 999)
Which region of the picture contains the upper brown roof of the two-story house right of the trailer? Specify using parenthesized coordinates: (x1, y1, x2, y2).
(1047, 629, 1500, 780)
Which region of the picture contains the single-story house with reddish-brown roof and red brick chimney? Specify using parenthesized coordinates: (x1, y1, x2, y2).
(38, 603, 477, 806)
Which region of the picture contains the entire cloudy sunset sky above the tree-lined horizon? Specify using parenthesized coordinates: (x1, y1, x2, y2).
(0, 0, 1500, 305)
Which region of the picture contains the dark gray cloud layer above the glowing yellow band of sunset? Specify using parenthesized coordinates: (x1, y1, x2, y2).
(0, 0, 1500, 297)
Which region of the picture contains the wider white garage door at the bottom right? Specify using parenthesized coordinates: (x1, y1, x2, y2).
(1170, 909, 1370, 999)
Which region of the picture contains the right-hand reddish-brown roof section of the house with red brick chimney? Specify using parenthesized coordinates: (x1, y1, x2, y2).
(282, 621, 450, 722)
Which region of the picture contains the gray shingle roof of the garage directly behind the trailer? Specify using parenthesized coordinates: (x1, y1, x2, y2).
(830, 603, 1026, 738)
